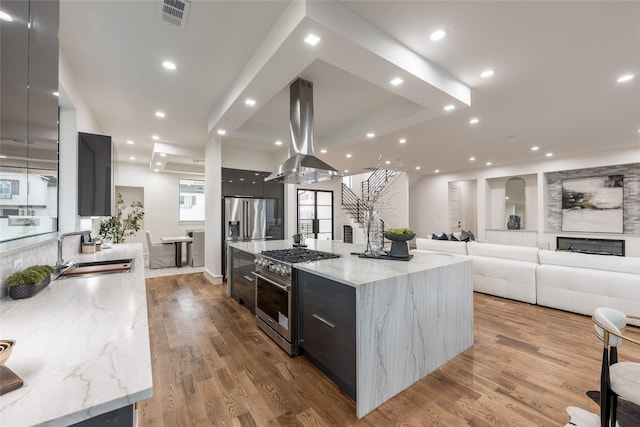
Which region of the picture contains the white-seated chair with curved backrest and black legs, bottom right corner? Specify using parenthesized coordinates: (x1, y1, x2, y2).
(592, 307, 640, 427)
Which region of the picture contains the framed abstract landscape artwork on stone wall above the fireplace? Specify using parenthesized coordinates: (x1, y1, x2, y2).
(562, 175, 624, 233)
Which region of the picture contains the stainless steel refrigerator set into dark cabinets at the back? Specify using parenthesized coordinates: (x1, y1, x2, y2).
(222, 197, 283, 277)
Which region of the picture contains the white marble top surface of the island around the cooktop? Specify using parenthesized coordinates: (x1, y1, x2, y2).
(229, 239, 466, 287)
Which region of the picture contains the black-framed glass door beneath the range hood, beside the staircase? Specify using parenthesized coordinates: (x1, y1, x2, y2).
(298, 190, 333, 240)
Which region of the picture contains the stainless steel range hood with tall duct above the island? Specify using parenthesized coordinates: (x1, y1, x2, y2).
(264, 78, 342, 184)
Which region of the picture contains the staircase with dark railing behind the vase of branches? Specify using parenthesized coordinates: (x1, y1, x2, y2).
(342, 169, 396, 246)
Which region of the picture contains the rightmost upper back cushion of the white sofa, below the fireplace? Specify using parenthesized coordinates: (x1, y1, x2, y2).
(539, 250, 640, 276)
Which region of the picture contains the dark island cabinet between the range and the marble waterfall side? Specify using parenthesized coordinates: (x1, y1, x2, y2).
(296, 270, 356, 400)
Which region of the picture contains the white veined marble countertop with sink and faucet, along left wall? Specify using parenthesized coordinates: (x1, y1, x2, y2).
(0, 243, 152, 427)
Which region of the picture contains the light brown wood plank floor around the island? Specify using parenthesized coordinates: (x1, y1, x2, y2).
(139, 273, 640, 427)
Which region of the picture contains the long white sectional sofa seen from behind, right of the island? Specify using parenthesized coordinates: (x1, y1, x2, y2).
(413, 238, 640, 326)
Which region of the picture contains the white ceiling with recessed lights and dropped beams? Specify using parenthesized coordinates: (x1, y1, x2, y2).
(60, 0, 640, 174)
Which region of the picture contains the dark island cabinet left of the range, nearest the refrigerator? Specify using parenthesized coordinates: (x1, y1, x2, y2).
(227, 247, 256, 314)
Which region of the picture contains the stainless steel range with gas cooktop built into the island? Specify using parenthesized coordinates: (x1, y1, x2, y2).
(253, 248, 340, 356)
